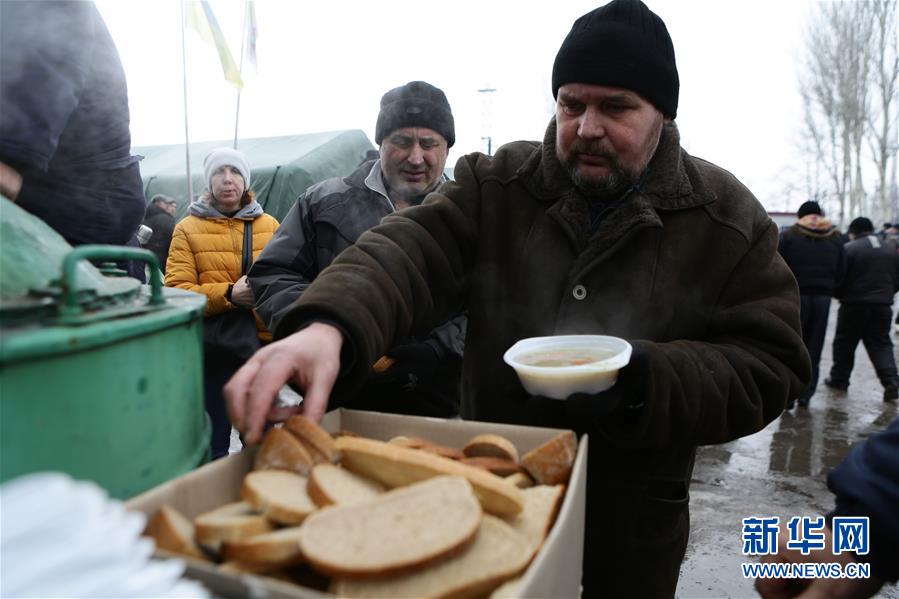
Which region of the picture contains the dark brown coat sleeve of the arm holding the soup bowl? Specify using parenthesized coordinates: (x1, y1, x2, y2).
(599, 213, 811, 447)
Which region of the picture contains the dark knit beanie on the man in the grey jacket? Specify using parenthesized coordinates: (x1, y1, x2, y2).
(375, 81, 456, 147)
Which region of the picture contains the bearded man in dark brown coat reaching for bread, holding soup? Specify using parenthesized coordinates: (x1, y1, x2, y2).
(225, 0, 811, 597)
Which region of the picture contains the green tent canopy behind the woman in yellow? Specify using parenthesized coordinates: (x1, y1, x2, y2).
(132, 129, 374, 221)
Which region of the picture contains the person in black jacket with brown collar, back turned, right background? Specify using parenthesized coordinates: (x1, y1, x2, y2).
(777, 201, 843, 410)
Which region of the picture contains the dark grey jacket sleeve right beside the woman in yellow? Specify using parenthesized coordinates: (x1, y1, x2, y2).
(247, 194, 318, 331)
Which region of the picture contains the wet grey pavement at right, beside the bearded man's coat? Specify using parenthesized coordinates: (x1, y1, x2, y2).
(677, 302, 899, 599)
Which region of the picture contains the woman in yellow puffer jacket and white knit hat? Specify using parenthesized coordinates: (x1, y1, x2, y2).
(165, 148, 278, 459)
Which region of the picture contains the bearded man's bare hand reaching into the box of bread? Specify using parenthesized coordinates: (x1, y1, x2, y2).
(224, 322, 343, 445)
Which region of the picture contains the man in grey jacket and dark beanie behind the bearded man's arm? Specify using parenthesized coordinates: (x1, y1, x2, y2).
(249, 81, 466, 417)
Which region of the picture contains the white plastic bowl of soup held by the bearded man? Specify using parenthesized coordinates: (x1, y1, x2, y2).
(503, 335, 631, 399)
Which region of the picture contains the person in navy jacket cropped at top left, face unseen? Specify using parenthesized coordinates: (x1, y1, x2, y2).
(0, 1, 146, 272)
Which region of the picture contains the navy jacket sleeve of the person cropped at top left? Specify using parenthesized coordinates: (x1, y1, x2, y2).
(0, 2, 96, 171)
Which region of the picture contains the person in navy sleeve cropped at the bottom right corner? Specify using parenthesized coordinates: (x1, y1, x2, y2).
(755, 418, 899, 599)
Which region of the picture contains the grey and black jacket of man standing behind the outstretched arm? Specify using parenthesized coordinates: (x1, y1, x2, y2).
(248, 161, 467, 417)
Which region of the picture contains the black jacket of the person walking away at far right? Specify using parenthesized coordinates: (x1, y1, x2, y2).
(834, 233, 899, 306)
